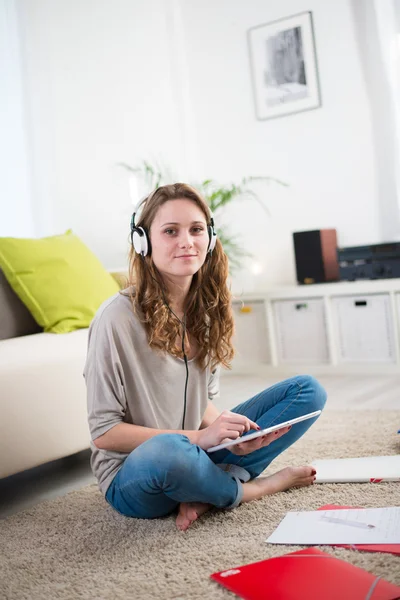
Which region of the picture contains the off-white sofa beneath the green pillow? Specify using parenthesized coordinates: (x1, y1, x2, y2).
(0, 271, 126, 478)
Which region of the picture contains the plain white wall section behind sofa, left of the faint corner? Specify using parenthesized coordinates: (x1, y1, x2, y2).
(20, 0, 189, 268)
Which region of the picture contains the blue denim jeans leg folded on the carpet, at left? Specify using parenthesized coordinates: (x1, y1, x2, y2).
(106, 433, 243, 519)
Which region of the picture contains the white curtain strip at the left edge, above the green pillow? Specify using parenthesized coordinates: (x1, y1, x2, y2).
(0, 0, 35, 237)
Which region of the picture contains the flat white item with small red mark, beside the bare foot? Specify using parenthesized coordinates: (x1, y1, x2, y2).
(311, 454, 400, 483)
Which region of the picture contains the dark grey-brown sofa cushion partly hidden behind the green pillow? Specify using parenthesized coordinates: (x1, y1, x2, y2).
(0, 269, 42, 340)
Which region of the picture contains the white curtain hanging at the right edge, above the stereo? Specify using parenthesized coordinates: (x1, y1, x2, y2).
(352, 0, 400, 241)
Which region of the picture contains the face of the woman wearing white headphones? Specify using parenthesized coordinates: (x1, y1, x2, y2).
(150, 199, 209, 279)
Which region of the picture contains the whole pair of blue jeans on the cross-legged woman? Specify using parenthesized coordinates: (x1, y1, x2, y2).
(106, 375, 326, 519)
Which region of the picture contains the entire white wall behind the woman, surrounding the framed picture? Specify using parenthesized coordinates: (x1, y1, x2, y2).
(14, 0, 390, 291)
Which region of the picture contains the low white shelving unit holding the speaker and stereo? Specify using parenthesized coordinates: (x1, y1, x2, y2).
(232, 279, 400, 373)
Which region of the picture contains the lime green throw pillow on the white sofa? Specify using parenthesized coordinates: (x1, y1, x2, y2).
(0, 230, 119, 333)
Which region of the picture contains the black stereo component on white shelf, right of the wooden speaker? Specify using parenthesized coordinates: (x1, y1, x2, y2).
(338, 242, 400, 281)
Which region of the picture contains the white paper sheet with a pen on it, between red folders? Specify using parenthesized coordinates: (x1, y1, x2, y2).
(266, 506, 400, 545)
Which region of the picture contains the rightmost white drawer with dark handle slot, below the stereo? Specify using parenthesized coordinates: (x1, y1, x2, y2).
(332, 294, 396, 363)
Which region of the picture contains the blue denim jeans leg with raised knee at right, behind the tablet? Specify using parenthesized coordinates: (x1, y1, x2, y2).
(210, 375, 326, 479)
